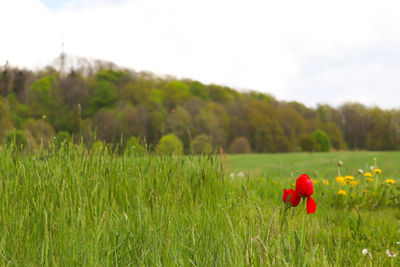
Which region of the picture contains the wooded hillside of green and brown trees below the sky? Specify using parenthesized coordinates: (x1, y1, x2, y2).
(0, 61, 400, 153)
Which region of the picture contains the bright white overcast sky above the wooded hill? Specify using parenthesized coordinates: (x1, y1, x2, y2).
(0, 0, 400, 108)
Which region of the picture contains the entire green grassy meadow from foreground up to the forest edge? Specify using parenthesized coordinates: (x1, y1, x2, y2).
(0, 146, 400, 266)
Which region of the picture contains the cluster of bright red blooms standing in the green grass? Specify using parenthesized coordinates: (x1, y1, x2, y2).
(283, 174, 317, 214)
